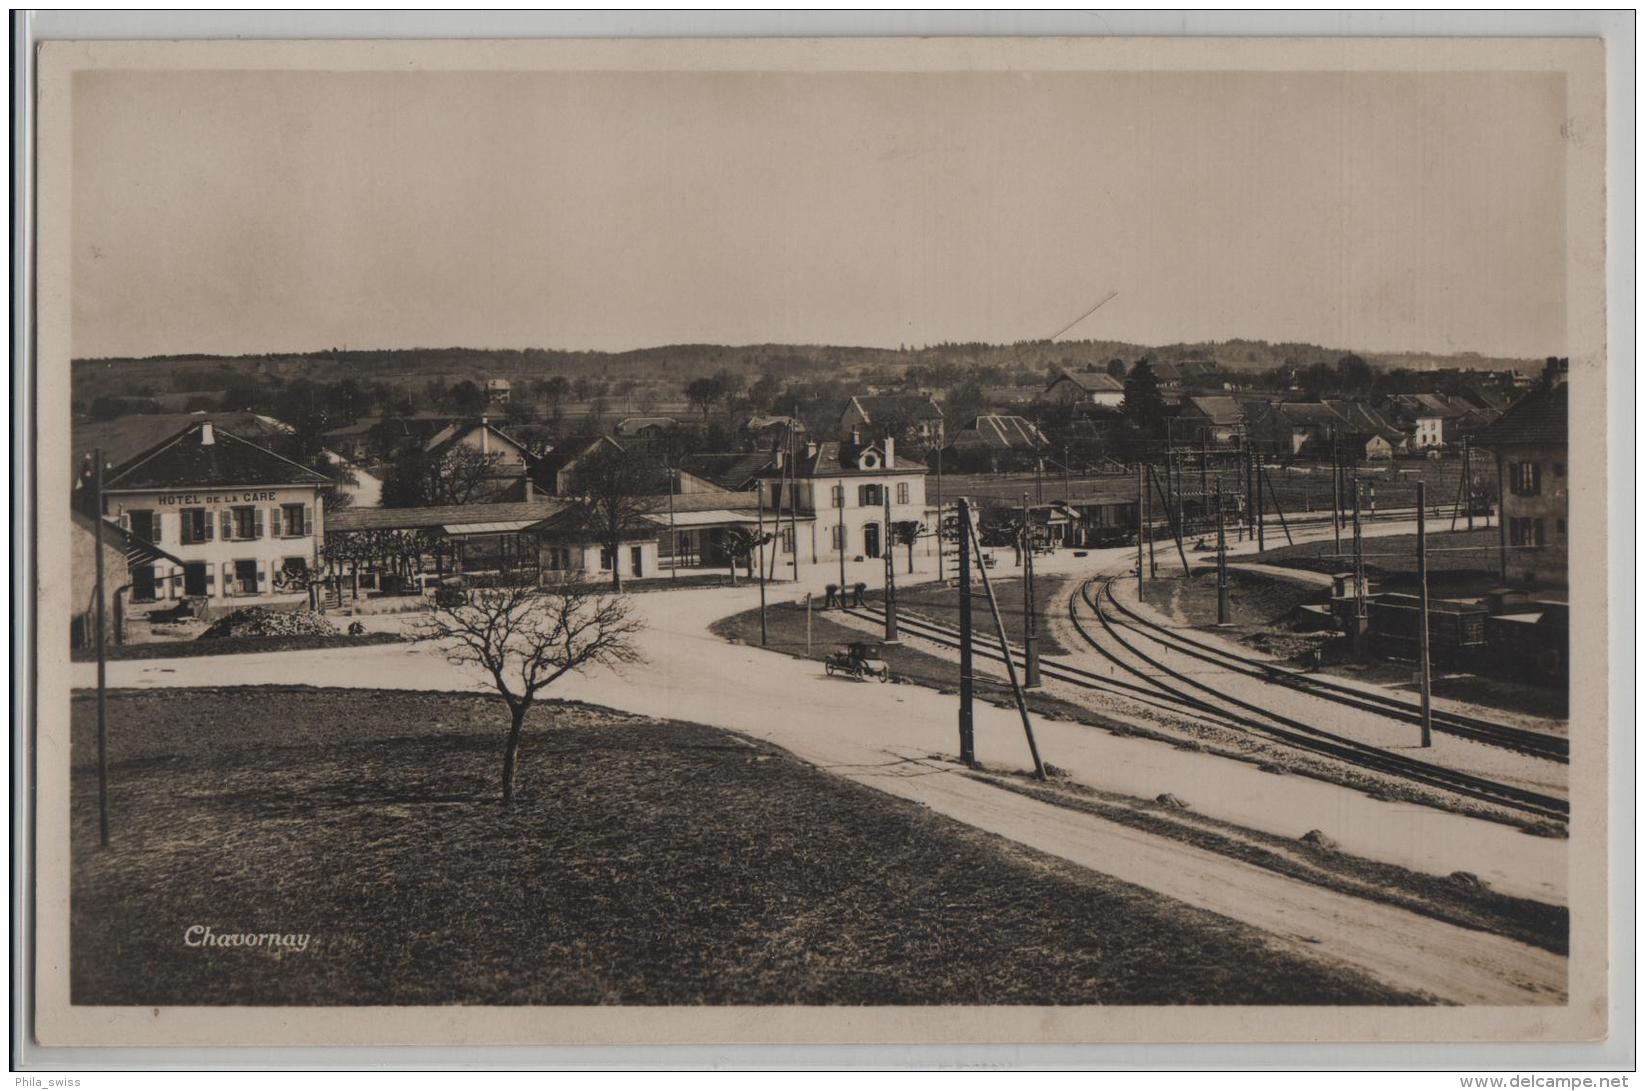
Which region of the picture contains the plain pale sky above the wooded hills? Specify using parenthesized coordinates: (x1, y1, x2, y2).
(71, 71, 1568, 357)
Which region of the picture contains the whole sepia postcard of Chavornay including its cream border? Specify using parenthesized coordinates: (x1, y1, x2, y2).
(22, 38, 1614, 1045)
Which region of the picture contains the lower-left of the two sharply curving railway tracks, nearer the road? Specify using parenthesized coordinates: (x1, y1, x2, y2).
(1069, 581, 1571, 821)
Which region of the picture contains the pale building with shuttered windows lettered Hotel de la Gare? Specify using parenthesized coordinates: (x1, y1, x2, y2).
(92, 420, 331, 602)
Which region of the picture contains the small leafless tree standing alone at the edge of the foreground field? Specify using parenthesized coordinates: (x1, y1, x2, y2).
(416, 574, 643, 803)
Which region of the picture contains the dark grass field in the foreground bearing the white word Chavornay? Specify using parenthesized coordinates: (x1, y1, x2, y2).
(71, 688, 1420, 1005)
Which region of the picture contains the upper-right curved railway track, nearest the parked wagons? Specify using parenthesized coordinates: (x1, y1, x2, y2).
(1105, 584, 1571, 764)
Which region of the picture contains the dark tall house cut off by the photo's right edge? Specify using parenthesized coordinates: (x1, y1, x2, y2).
(1477, 360, 1569, 587)
